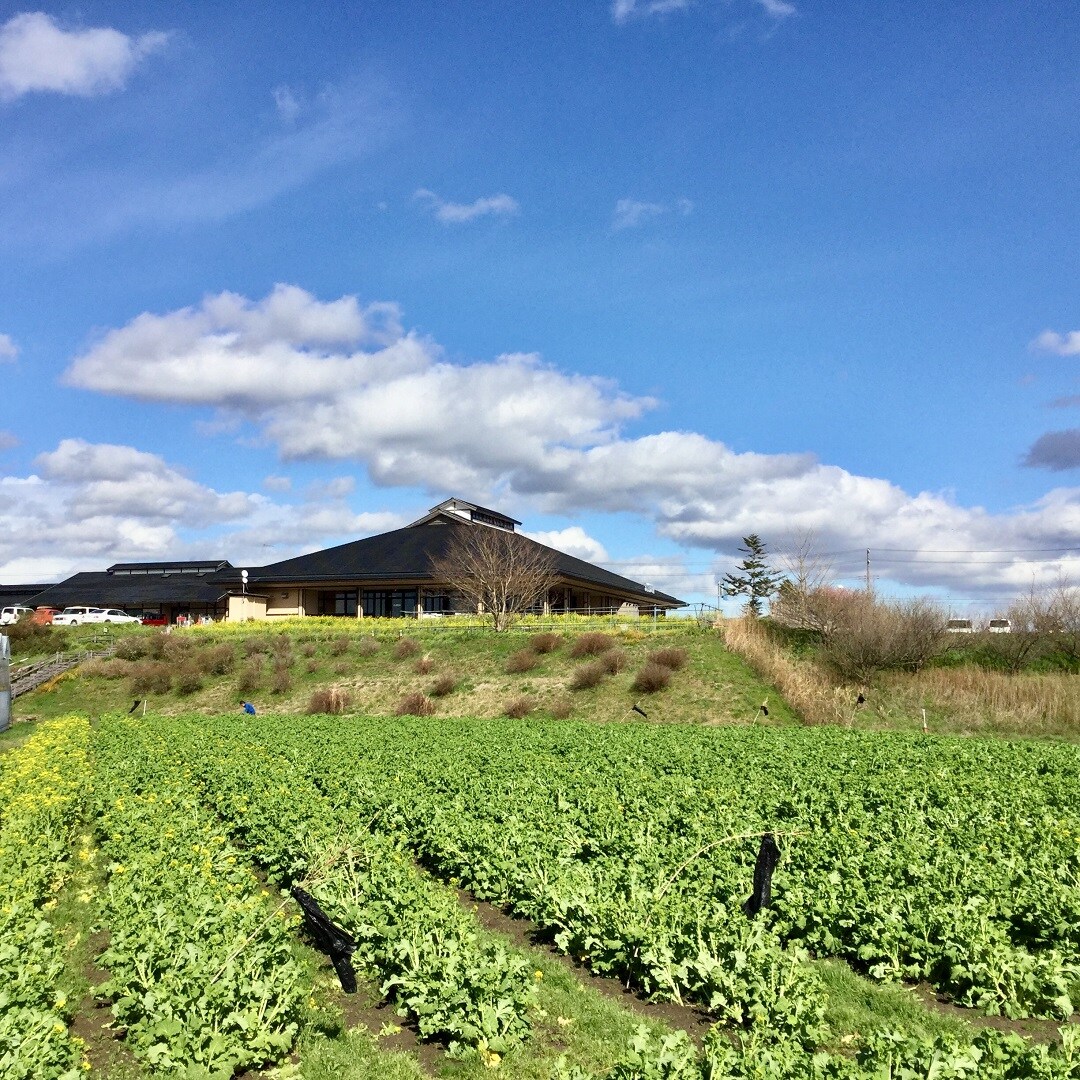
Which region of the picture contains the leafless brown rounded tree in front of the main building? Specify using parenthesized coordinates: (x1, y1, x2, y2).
(431, 525, 558, 630)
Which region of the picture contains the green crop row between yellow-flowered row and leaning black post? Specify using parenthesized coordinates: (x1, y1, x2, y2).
(95, 723, 307, 1078)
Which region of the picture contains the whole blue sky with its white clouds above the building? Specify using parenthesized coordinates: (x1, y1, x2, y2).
(0, 0, 1080, 613)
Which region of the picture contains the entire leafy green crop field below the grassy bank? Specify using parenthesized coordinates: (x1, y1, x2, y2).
(0, 695, 1080, 1080)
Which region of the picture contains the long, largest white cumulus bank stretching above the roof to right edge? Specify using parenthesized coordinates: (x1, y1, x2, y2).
(61, 285, 1080, 588)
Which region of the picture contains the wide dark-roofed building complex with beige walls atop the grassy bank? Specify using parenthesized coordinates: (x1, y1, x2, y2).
(23, 499, 685, 622)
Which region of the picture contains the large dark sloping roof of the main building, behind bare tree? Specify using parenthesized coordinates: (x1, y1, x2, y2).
(249, 515, 685, 607)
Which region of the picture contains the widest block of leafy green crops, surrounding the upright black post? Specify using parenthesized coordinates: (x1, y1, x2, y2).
(267, 721, 1080, 1022)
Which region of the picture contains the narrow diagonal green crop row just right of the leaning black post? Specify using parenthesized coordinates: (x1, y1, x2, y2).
(99, 720, 534, 1054)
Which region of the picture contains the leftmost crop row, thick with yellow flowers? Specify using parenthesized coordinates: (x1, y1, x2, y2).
(0, 718, 90, 1080)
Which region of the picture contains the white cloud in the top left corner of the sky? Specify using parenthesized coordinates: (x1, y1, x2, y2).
(0, 11, 168, 100)
